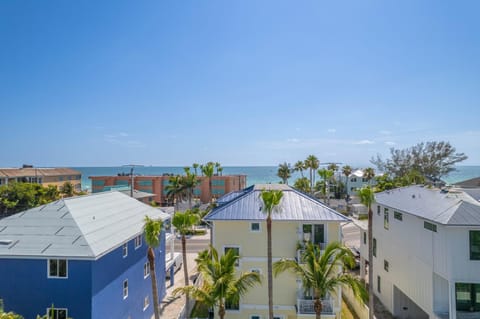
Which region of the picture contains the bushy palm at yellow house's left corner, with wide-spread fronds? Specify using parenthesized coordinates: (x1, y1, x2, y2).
(173, 246, 261, 319)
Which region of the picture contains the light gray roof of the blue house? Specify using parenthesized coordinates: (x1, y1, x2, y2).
(0, 192, 169, 259)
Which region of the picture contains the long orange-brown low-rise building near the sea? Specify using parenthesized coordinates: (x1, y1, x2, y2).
(88, 174, 247, 206)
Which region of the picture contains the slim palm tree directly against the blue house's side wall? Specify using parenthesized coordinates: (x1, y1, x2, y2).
(143, 216, 163, 319)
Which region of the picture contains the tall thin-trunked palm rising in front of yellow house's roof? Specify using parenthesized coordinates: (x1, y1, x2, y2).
(260, 189, 283, 319)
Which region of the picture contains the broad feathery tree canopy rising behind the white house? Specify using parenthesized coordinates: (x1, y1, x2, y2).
(370, 141, 467, 180)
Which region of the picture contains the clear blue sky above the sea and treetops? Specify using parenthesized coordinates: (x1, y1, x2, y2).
(0, 0, 480, 166)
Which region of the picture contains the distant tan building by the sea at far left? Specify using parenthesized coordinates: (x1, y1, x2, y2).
(0, 165, 82, 191)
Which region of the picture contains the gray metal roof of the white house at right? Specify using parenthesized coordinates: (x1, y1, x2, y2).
(375, 185, 480, 226)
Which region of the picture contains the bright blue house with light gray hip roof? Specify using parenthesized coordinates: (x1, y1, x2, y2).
(0, 192, 169, 319)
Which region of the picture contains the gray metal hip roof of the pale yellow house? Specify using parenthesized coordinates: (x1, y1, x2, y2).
(204, 184, 350, 222)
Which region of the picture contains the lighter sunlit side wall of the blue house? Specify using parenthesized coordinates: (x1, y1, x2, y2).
(92, 232, 165, 319)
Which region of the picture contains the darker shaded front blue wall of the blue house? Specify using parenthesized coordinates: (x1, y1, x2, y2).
(0, 259, 92, 319)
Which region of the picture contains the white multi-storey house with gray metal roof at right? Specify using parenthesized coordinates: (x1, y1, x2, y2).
(360, 186, 480, 319)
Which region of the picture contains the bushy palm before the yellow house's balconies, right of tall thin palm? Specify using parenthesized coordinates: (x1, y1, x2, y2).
(273, 242, 368, 319)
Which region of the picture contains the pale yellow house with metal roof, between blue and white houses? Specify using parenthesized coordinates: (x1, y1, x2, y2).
(204, 184, 349, 319)
